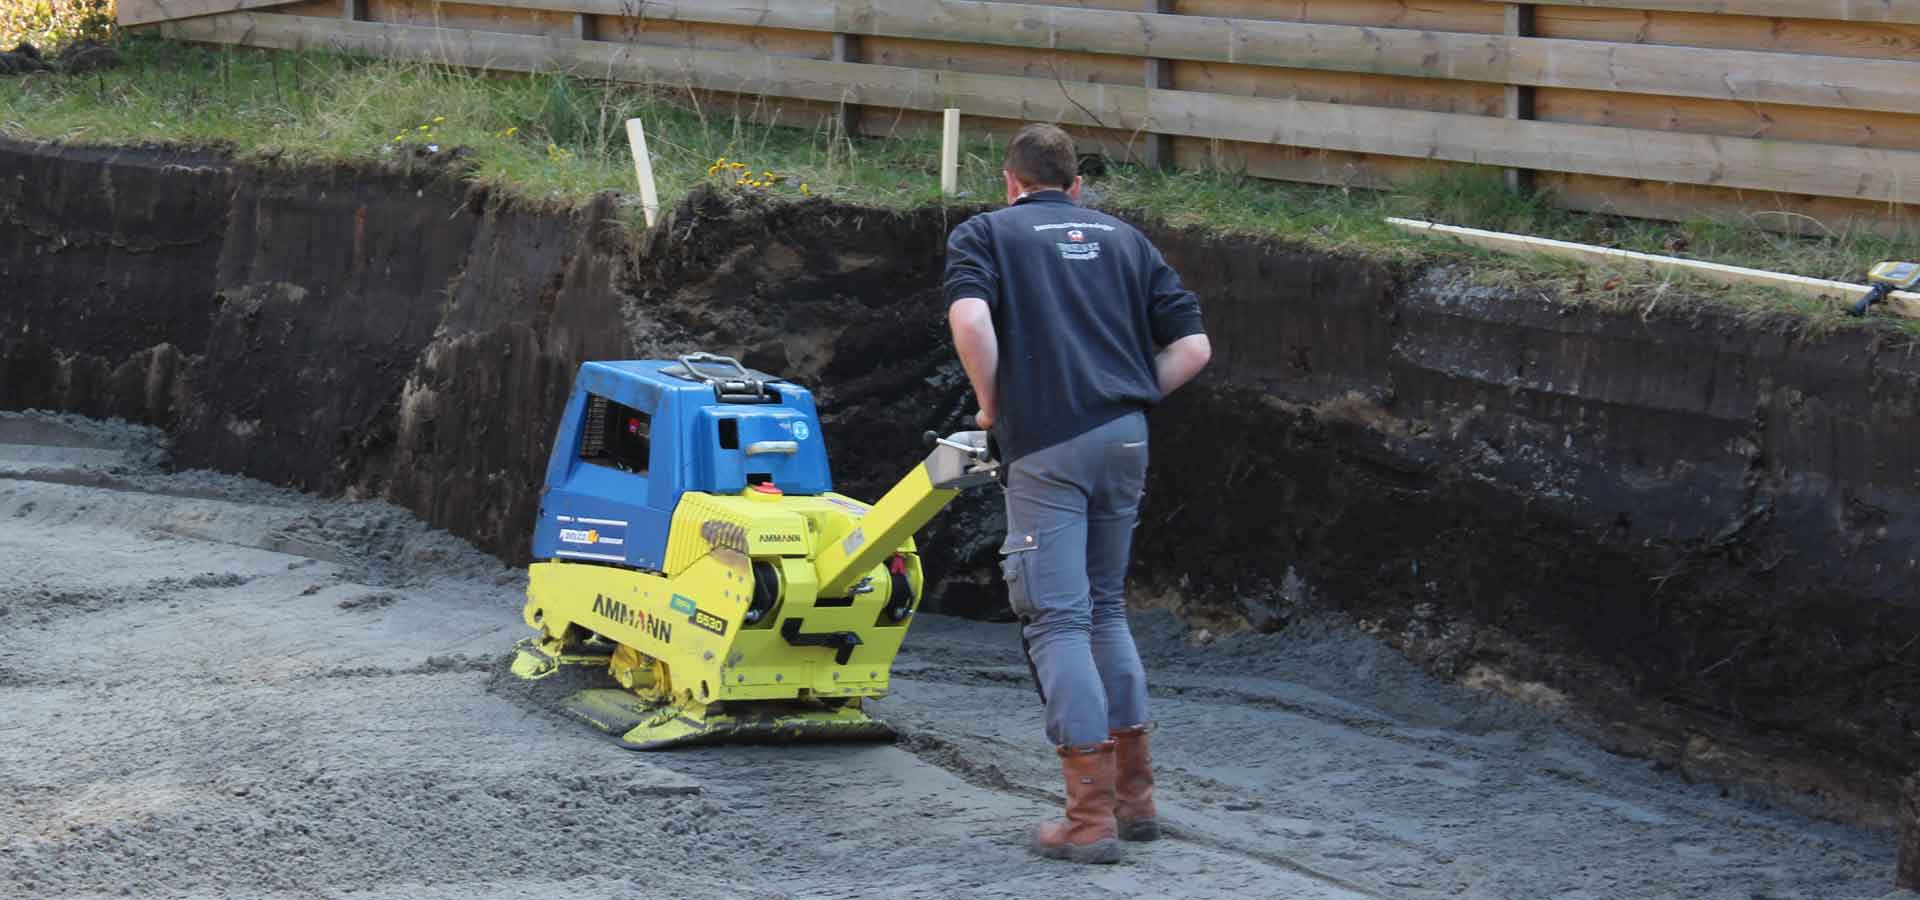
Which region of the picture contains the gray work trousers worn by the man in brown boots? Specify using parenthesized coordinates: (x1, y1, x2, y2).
(1000, 413, 1146, 746)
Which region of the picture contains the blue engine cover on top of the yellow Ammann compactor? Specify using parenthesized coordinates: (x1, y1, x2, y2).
(534, 361, 833, 570)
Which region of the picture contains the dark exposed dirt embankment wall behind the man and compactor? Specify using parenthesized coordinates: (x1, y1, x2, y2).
(0, 144, 1920, 821)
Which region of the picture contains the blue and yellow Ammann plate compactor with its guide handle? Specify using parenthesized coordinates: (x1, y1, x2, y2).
(513, 353, 998, 750)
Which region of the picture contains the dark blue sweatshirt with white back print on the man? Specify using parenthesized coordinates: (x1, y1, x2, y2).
(947, 190, 1204, 462)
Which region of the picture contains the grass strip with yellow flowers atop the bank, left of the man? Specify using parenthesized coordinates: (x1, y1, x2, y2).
(0, 38, 983, 215)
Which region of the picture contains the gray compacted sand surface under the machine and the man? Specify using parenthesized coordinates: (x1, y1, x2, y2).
(0, 414, 1893, 900)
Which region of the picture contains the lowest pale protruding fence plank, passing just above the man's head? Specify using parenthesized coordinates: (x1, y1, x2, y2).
(161, 13, 1920, 203)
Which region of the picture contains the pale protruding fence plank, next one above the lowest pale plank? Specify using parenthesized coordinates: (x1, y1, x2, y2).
(428, 0, 1920, 113)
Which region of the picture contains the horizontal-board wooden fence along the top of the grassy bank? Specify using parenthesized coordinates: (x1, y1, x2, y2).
(119, 0, 1920, 230)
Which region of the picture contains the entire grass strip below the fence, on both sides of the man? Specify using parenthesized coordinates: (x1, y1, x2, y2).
(0, 38, 1903, 324)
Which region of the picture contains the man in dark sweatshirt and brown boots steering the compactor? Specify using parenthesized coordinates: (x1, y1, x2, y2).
(947, 125, 1212, 862)
